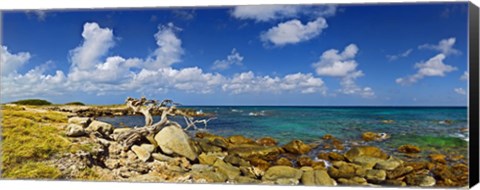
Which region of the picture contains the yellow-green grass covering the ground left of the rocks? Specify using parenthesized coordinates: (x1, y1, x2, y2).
(0, 106, 97, 179)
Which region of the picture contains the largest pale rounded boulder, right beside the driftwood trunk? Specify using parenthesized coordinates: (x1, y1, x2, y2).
(155, 126, 197, 161)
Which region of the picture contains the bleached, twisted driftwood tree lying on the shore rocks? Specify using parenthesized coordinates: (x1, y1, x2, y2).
(115, 97, 214, 150)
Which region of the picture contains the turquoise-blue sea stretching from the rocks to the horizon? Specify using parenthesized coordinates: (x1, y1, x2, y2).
(98, 106, 468, 155)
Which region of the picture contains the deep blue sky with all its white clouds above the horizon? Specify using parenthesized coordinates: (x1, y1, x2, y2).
(1, 3, 468, 106)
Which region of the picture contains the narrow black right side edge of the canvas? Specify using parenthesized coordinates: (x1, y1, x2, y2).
(468, 2, 480, 188)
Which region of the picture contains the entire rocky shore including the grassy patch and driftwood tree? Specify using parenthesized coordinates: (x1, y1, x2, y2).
(1, 98, 468, 187)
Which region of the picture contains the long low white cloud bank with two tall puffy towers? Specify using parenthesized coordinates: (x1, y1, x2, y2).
(2, 23, 334, 98)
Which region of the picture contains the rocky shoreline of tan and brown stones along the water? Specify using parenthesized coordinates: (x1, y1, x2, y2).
(59, 110, 468, 187)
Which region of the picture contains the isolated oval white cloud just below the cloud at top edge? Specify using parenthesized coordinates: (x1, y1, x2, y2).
(260, 17, 328, 46)
